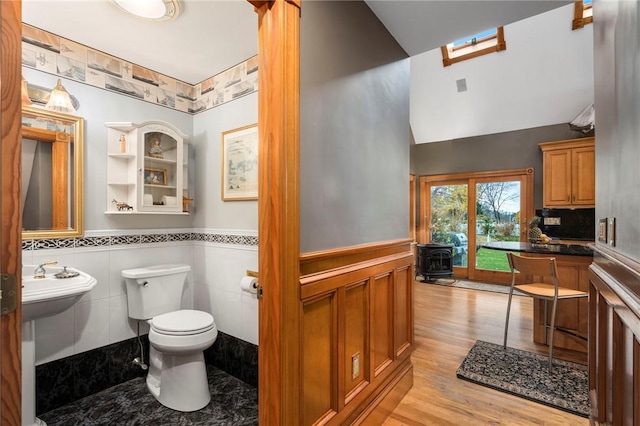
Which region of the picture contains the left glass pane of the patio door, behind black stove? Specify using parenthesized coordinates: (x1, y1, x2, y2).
(429, 183, 469, 268)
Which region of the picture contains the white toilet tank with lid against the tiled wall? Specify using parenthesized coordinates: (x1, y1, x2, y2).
(122, 264, 191, 320)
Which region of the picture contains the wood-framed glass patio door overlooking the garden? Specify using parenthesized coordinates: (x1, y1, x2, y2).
(418, 168, 533, 283)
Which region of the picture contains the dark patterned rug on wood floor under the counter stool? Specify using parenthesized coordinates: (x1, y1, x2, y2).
(456, 340, 589, 417)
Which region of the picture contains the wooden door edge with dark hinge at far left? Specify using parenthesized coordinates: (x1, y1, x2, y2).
(0, 1, 22, 426)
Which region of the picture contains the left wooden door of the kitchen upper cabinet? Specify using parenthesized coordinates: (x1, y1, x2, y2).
(543, 150, 572, 207)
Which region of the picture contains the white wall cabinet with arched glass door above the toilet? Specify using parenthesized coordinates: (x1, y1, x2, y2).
(105, 121, 189, 214)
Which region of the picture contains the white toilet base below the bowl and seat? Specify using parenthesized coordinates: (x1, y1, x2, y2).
(147, 346, 211, 412)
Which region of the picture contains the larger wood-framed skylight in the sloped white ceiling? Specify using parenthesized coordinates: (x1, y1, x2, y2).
(440, 27, 507, 67)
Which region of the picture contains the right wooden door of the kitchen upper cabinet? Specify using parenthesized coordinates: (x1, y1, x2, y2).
(571, 146, 596, 206)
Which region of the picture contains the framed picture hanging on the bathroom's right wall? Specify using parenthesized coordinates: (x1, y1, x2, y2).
(221, 123, 258, 201)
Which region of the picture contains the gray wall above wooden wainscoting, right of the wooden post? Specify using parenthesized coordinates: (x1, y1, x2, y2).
(300, 1, 410, 252)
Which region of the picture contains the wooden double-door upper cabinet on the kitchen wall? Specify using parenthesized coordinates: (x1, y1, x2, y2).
(539, 137, 596, 208)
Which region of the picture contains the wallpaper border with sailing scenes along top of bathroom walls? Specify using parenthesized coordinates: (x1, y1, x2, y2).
(22, 23, 258, 114)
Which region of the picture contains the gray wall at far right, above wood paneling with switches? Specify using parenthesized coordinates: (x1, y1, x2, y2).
(593, 1, 640, 261)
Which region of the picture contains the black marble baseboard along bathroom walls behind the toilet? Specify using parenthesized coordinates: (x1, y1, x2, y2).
(36, 332, 258, 414)
